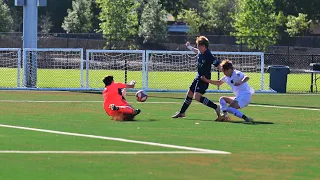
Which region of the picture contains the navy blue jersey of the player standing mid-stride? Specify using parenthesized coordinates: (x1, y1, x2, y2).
(196, 49, 220, 79)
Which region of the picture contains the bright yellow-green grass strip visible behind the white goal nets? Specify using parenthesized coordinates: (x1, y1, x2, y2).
(0, 68, 311, 92)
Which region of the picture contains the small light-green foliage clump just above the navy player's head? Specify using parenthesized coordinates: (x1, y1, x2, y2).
(178, 9, 202, 35)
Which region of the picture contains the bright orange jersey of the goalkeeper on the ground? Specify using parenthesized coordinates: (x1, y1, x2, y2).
(102, 82, 128, 108)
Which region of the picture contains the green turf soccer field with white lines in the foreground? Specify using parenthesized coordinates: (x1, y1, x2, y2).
(0, 91, 320, 180)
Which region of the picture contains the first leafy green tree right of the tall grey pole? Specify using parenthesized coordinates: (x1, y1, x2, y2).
(62, 0, 93, 33)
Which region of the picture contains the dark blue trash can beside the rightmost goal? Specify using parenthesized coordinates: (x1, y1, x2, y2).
(268, 65, 290, 93)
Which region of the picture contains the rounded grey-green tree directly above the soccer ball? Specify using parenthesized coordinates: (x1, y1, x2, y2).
(139, 0, 168, 43)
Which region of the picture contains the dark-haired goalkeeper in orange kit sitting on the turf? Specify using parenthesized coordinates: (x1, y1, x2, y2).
(102, 76, 141, 121)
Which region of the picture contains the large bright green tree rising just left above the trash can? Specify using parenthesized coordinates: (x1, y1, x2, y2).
(231, 0, 284, 51)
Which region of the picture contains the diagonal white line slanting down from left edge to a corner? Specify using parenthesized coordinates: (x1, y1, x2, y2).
(0, 124, 230, 154)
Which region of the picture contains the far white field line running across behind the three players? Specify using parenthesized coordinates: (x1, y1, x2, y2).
(0, 100, 320, 111)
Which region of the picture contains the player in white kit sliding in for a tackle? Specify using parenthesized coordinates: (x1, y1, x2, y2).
(201, 60, 254, 122)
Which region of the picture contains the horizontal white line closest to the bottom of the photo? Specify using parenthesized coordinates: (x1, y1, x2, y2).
(0, 150, 225, 154)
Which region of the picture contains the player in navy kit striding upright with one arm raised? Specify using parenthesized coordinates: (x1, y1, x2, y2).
(172, 36, 221, 119)
